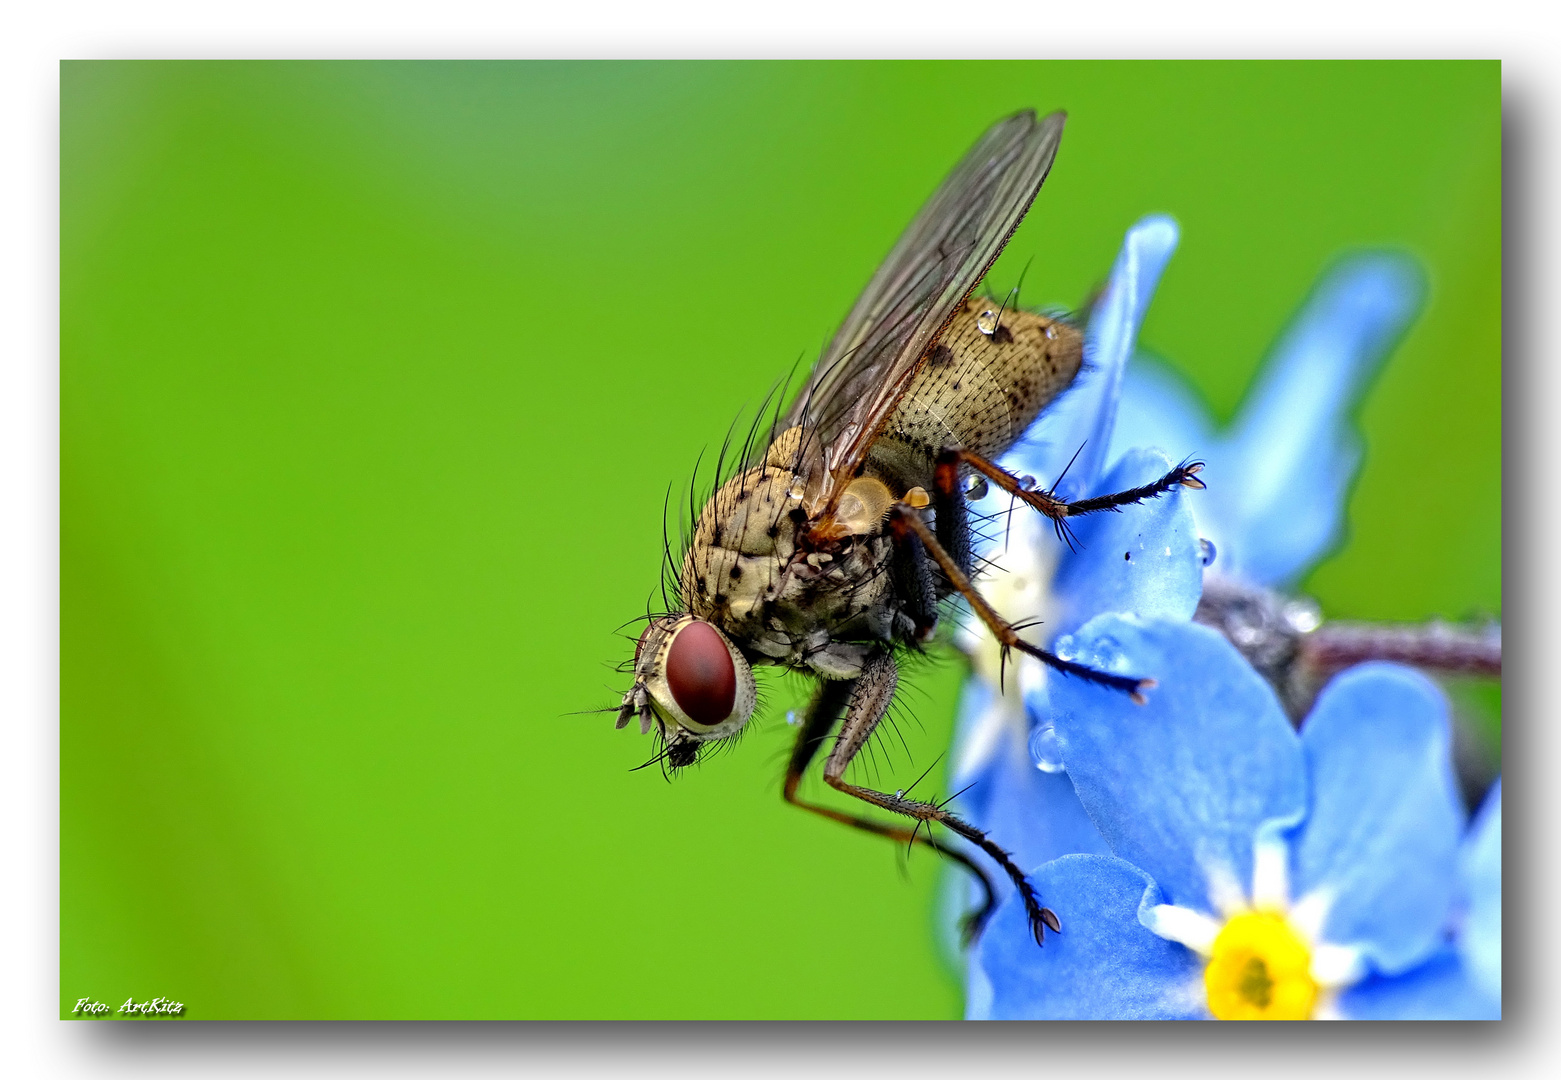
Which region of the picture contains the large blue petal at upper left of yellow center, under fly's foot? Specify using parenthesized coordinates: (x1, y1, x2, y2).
(1051, 615, 1305, 911)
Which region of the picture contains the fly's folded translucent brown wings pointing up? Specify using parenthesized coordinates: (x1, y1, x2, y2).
(782, 109, 1066, 518)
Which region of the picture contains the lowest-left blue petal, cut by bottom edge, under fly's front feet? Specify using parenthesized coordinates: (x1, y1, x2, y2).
(969, 855, 1207, 1019)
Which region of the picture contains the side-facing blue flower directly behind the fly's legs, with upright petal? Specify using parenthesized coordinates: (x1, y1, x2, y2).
(954, 215, 1205, 891)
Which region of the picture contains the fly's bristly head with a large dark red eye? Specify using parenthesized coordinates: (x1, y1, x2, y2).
(618, 615, 757, 769)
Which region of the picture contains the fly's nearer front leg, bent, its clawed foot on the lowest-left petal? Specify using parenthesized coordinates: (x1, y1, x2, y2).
(824, 652, 1061, 944)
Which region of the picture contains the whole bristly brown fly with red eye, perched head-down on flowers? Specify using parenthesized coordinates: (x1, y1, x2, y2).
(618, 111, 1204, 944)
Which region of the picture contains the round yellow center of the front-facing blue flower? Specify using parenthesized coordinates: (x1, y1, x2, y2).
(1204, 911, 1317, 1021)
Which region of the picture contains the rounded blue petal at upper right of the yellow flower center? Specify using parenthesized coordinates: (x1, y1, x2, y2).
(1293, 663, 1464, 975)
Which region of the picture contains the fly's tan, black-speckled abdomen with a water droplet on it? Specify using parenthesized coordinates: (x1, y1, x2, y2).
(884, 297, 1083, 457)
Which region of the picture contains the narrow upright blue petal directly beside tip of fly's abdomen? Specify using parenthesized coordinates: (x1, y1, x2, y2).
(1004, 215, 1177, 499)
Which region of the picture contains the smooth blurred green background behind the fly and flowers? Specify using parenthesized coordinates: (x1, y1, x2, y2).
(61, 62, 1502, 1019)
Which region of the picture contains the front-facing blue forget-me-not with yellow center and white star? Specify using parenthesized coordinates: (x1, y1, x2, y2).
(968, 615, 1500, 1019)
